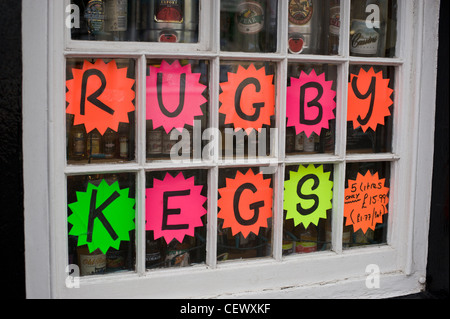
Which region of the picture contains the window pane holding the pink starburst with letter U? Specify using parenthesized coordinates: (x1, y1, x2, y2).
(146, 60, 209, 160)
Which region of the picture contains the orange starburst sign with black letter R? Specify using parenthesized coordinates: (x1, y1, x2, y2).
(66, 60, 135, 135)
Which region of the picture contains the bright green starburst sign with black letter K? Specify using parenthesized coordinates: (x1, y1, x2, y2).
(67, 180, 135, 254)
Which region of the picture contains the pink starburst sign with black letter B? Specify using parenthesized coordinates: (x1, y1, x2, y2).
(286, 70, 336, 137)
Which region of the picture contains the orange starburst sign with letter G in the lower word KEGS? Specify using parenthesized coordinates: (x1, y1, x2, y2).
(217, 169, 273, 238)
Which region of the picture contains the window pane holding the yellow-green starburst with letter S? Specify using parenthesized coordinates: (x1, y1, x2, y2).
(283, 164, 333, 256)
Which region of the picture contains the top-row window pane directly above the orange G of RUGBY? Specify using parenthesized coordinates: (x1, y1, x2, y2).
(220, 0, 278, 52)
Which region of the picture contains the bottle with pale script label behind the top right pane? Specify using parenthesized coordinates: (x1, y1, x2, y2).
(350, 0, 387, 57)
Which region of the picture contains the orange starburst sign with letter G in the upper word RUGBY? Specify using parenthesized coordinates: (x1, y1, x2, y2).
(219, 64, 275, 134)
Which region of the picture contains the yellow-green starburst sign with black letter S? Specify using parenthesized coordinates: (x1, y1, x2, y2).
(284, 164, 333, 229)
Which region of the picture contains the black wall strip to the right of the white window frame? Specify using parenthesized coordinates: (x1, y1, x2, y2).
(427, 0, 450, 298)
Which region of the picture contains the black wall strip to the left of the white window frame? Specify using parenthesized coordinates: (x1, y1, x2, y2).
(0, 0, 25, 298)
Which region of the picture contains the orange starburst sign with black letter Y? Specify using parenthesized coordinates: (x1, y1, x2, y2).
(347, 68, 394, 132)
